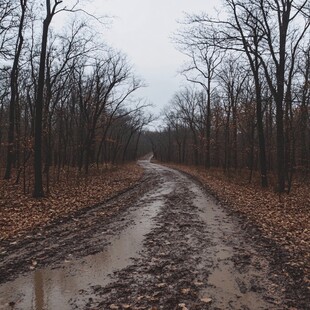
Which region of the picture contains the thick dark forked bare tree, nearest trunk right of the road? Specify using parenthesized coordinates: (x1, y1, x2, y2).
(226, 0, 310, 192)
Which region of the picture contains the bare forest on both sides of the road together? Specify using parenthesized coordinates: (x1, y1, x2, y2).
(0, 0, 310, 197)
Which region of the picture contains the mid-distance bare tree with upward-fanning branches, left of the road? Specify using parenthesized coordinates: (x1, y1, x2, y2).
(78, 51, 142, 173)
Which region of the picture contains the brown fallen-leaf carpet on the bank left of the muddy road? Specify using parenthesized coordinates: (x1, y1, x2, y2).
(0, 164, 143, 241)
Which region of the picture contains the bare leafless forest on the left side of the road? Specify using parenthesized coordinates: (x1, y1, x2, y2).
(0, 0, 152, 197)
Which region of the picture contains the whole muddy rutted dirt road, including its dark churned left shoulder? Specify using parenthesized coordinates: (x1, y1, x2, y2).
(0, 161, 306, 310)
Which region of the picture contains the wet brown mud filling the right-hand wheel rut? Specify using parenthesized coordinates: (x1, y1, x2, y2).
(191, 179, 282, 309)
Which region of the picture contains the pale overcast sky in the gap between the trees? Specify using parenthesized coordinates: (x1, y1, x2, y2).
(74, 0, 221, 128)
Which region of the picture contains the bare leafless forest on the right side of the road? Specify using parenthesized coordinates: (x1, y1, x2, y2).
(152, 0, 310, 193)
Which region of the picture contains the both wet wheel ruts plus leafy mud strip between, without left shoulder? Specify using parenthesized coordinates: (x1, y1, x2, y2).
(0, 161, 292, 310)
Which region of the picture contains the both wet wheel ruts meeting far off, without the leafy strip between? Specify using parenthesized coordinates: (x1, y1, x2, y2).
(0, 162, 284, 310)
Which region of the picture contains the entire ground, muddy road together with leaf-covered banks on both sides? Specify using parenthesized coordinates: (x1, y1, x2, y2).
(0, 161, 310, 310)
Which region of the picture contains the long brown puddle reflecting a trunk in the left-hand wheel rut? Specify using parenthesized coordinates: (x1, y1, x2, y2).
(0, 189, 163, 310)
